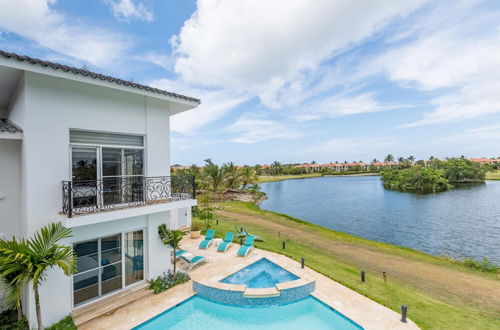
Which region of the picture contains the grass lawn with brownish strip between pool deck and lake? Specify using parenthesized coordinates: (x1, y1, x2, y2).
(193, 202, 500, 329)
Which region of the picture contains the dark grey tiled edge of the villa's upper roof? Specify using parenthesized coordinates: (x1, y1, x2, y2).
(0, 50, 201, 103)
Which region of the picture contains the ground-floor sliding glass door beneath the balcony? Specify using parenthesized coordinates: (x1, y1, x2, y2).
(73, 230, 144, 306)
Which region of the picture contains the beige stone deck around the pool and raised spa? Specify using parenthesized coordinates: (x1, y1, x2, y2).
(79, 237, 419, 330)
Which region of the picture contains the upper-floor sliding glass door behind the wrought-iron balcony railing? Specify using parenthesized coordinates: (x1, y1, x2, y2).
(70, 130, 144, 208)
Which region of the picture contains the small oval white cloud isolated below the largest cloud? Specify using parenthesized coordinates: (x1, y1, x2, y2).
(226, 116, 302, 144)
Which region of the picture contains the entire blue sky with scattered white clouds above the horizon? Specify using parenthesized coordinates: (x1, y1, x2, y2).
(0, 0, 500, 165)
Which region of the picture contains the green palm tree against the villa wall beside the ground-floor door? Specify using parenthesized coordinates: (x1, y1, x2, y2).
(0, 222, 76, 330)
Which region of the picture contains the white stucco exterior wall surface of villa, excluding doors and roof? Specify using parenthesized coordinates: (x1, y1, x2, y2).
(7, 72, 190, 326)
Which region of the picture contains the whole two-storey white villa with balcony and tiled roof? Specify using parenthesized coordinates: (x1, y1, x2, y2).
(0, 51, 200, 326)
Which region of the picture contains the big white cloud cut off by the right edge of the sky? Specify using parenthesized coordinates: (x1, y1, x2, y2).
(375, 1, 500, 127)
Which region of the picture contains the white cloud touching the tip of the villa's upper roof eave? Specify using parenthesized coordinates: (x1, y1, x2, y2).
(148, 79, 250, 135)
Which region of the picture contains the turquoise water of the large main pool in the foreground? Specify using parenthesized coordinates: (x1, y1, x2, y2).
(134, 296, 363, 330)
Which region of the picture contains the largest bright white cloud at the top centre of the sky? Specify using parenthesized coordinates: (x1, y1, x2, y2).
(172, 0, 425, 107)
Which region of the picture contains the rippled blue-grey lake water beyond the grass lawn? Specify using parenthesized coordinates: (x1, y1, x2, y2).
(260, 176, 500, 264)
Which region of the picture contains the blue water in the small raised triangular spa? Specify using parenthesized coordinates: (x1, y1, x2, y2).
(221, 258, 299, 288)
